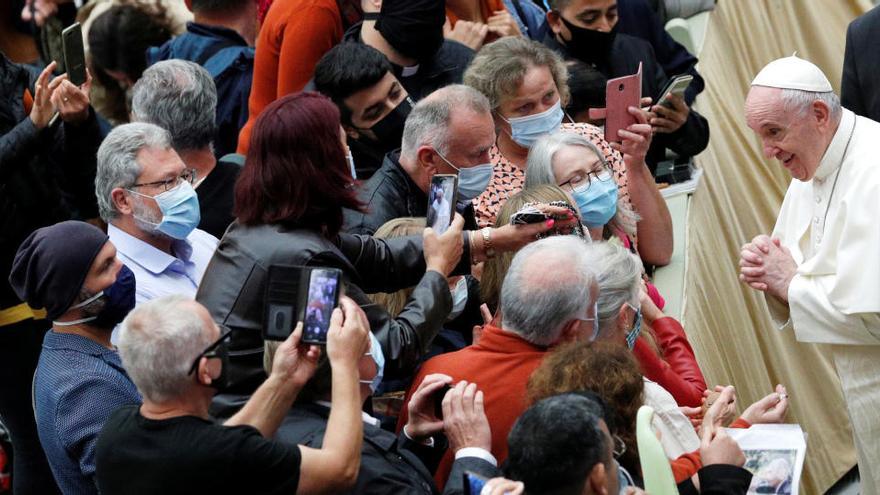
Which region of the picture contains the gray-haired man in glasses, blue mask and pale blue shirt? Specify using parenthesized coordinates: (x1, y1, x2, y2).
(95, 123, 218, 304)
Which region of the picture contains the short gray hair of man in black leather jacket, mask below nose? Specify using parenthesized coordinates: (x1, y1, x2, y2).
(400, 84, 491, 161)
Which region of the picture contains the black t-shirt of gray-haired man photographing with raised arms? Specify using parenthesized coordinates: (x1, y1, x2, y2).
(95, 406, 301, 495)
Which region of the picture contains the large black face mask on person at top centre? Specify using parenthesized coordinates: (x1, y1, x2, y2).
(364, 0, 446, 62)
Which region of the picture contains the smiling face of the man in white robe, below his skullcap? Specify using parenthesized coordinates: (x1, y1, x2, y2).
(745, 85, 842, 181)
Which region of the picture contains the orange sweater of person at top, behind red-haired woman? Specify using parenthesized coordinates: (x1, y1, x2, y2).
(238, 0, 343, 154)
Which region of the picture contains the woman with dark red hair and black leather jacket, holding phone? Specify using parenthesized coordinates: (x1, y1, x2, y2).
(196, 93, 470, 417)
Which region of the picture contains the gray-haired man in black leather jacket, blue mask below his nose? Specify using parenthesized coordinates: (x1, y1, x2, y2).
(345, 84, 570, 262)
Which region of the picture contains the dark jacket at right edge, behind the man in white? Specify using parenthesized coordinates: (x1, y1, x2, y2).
(840, 7, 880, 121)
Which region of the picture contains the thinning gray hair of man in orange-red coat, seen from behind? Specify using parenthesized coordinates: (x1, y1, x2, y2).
(500, 235, 596, 346)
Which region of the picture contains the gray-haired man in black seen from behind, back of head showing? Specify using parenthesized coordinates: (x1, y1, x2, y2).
(131, 60, 241, 238)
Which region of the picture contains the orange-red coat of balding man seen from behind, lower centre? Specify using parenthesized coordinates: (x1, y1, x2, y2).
(397, 325, 547, 489)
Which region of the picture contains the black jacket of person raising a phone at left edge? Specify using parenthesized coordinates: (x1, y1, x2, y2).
(0, 53, 102, 309)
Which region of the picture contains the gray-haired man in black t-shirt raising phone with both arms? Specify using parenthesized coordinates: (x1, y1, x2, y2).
(95, 296, 370, 495)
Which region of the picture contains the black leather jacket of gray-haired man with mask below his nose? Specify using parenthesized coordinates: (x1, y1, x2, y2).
(344, 150, 477, 235)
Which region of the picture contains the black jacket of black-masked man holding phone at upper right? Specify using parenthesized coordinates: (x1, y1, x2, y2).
(544, 32, 709, 172)
